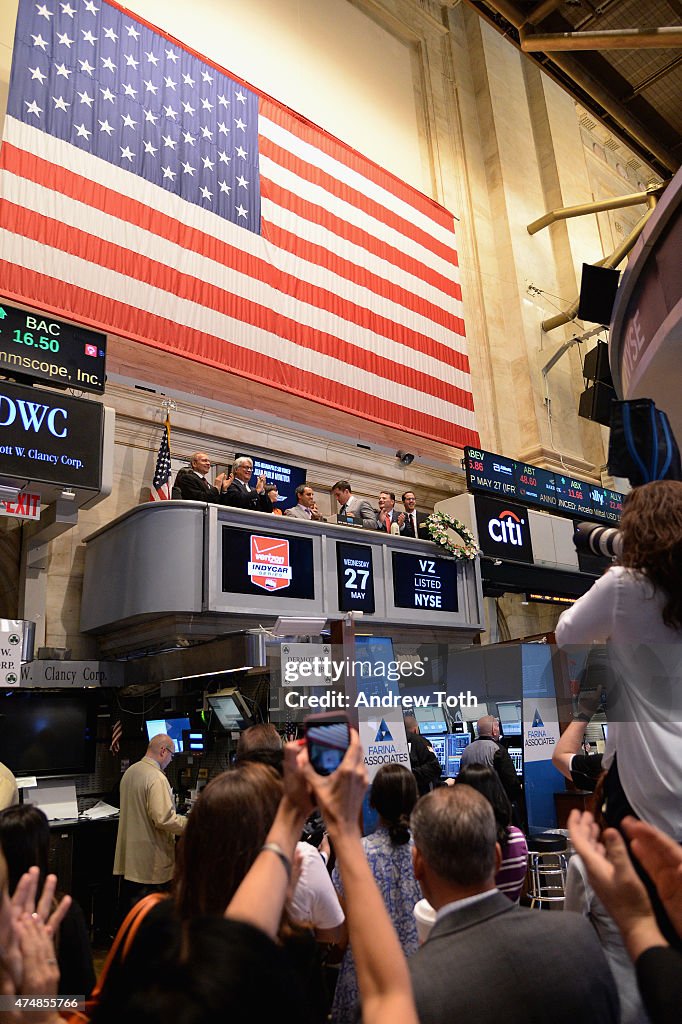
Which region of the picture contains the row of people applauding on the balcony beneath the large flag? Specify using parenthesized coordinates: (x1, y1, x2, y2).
(171, 452, 430, 541)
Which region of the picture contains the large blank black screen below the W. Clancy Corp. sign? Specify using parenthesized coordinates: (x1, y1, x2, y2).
(0, 689, 96, 778)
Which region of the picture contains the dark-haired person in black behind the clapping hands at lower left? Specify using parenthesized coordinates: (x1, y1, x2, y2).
(0, 804, 95, 995)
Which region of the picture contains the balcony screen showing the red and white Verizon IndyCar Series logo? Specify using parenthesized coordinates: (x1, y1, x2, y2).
(222, 526, 315, 601)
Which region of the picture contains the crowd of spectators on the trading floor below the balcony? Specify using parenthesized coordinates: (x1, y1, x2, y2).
(0, 481, 682, 1024)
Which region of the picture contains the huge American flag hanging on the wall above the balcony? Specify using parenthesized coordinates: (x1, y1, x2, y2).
(0, 0, 479, 446)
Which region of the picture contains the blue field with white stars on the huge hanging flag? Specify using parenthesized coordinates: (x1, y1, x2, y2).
(8, 0, 260, 232)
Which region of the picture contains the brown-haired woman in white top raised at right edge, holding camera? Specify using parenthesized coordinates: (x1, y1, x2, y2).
(556, 480, 682, 943)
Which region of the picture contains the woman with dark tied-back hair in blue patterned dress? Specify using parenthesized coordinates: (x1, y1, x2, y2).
(332, 765, 422, 1024)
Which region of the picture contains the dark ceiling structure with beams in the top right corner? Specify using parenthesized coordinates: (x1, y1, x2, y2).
(466, 0, 682, 180)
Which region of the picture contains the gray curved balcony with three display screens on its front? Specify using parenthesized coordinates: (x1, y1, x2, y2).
(81, 501, 483, 654)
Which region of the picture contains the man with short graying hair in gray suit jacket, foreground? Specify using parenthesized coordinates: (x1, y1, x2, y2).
(409, 785, 620, 1024)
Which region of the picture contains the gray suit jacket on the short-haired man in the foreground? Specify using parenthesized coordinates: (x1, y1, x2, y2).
(408, 893, 620, 1024)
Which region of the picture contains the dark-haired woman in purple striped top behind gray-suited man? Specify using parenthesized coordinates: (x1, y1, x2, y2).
(457, 764, 528, 903)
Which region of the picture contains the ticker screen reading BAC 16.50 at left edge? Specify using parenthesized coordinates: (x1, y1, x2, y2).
(0, 302, 106, 394)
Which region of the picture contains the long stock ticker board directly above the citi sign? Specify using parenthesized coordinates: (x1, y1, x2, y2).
(464, 447, 624, 523)
